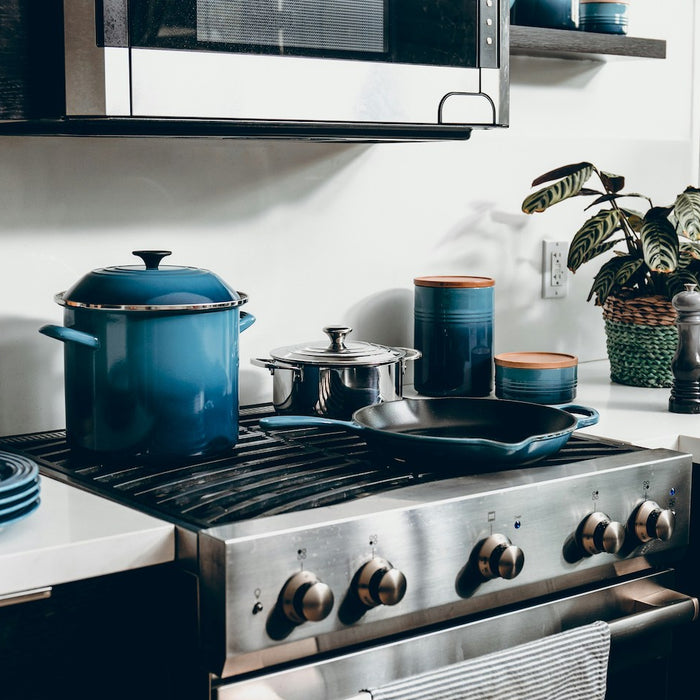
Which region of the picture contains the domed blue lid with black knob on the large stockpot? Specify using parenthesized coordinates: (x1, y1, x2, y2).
(55, 250, 248, 311)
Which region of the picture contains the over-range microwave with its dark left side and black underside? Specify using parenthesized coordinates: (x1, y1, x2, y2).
(0, 0, 510, 140)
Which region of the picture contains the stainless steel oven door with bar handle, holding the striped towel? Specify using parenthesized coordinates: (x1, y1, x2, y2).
(212, 570, 698, 700)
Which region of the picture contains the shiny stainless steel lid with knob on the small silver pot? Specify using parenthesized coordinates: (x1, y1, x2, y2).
(270, 326, 414, 366)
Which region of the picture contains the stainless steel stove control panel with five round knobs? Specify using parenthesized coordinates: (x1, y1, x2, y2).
(204, 442, 692, 672)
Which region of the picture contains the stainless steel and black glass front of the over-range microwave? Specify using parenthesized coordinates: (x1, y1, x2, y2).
(65, 0, 508, 128)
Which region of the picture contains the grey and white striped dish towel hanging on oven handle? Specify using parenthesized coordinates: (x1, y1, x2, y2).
(366, 622, 610, 700)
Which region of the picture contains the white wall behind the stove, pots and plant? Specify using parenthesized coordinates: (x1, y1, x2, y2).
(0, 0, 699, 434)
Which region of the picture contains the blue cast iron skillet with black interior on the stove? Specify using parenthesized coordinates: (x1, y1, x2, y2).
(260, 397, 599, 470)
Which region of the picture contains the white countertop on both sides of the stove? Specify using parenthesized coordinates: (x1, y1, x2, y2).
(0, 361, 700, 596)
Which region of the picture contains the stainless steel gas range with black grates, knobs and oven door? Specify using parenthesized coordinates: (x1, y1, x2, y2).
(0, 405, 698, 700)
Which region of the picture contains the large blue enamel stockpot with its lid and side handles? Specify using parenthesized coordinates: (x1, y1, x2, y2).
(40, 251, 255, 460)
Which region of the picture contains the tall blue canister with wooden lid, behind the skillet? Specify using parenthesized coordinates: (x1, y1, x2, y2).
(413, 275, 496, 396)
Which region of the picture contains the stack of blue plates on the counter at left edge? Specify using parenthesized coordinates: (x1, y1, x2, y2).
(0, 451, 40, 528)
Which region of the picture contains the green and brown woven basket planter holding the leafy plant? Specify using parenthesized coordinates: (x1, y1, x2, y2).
(603, 295, 678, 387)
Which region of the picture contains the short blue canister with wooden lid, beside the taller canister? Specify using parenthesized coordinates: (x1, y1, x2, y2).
(494, 352, 578, 404)
